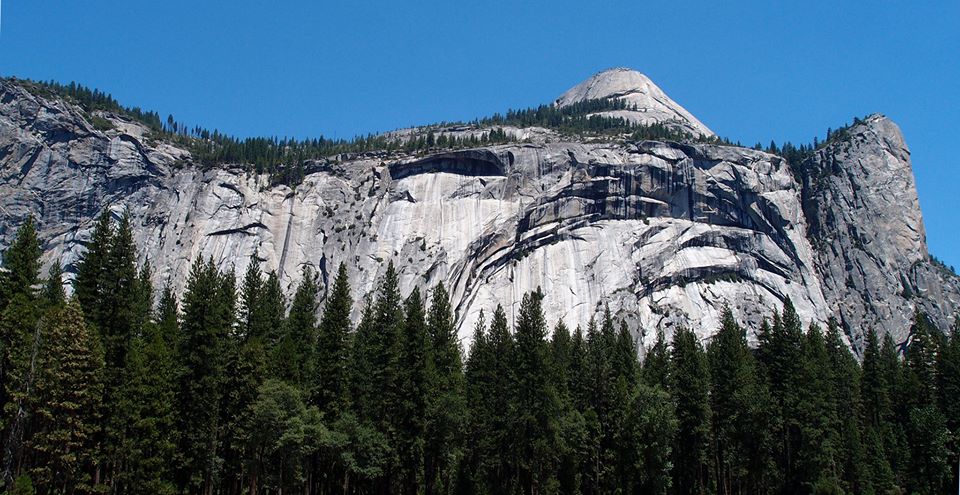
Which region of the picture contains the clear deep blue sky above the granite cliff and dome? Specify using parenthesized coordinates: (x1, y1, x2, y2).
(0, 0, 960, 268)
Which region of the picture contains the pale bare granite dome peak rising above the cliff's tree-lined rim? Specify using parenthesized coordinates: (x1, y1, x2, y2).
(554, 67, 714, 137)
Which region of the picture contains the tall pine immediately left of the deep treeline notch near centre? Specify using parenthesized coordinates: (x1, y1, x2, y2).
(424, 284, 467, 495)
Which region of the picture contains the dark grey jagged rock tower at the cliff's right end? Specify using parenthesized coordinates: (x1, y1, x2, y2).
(799, 115, 960, 350)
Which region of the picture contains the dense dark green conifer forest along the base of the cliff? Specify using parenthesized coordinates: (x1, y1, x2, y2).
(0, 213, 960, 495)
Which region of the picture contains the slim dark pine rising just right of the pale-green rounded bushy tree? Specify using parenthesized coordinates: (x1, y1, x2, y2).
(312, 263, 353, 416)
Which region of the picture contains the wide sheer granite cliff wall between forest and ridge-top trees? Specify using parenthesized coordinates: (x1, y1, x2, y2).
(0, 73, 960, 346)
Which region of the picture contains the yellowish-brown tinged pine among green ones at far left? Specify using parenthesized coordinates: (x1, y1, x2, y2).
(29, 301, 104, 493)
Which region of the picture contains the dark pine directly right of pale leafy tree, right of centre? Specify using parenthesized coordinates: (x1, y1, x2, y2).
(670, 327, 712, 493)
